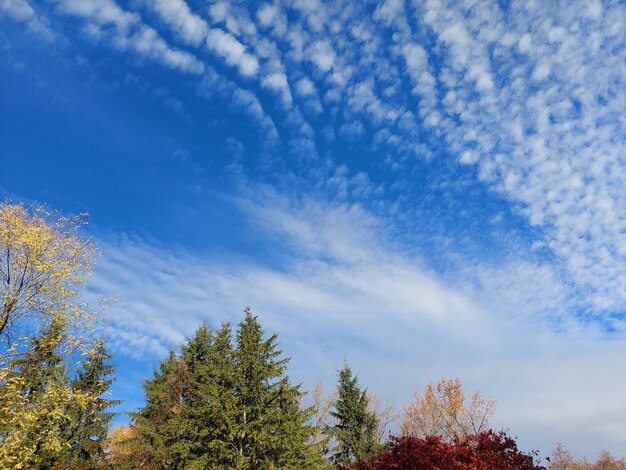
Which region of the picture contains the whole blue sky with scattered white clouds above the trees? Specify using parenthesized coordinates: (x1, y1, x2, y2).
(0, 0, 626, 458)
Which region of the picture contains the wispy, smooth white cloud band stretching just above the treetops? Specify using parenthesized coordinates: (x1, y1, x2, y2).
(91, 188, 626, 453)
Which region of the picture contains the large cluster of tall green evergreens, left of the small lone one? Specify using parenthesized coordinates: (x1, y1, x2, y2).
(125, 308, 322, 470)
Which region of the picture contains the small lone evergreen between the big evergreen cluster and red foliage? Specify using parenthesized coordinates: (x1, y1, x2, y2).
(330, 364, 380, 464)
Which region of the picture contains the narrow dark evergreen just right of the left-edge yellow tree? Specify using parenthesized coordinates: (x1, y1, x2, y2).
(64, 340, 121, 468)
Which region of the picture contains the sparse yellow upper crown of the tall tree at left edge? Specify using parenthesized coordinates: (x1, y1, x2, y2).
(0, 201, 95, 346)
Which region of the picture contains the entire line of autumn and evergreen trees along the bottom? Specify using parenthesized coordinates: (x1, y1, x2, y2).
(0, 201, 626, 470)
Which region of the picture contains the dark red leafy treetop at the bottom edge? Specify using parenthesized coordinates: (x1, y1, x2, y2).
(353, 431, 545, 470)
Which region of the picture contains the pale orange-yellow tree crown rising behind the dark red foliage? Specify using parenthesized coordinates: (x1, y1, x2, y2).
(401, 379, 496, 441)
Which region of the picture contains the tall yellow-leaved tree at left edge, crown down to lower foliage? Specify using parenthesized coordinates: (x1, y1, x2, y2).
(0, 201, 110, 469)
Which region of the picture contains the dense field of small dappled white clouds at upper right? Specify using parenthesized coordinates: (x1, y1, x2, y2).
(400, 2, 626, 313)
